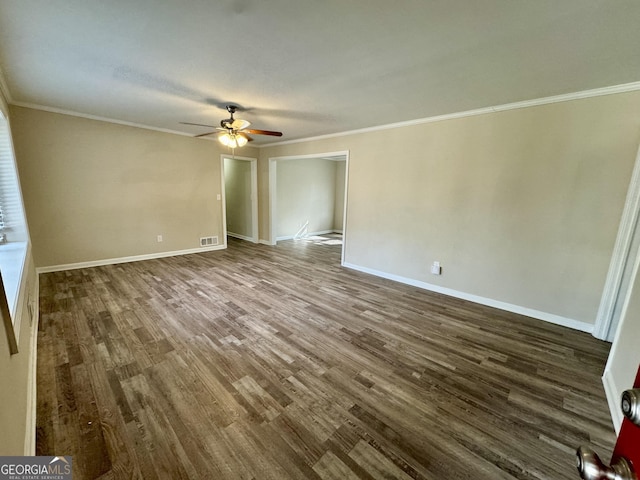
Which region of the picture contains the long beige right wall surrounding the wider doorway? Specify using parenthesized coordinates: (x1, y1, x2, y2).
(259, 92, 640, 328)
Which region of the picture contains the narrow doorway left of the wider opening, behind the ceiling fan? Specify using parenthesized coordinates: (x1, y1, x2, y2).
(221, 155, 258, 243)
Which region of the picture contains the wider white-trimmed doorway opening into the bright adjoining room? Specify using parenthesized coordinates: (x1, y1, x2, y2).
(269, 151, 349, 262)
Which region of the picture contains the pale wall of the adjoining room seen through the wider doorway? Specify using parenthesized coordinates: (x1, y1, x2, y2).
(276, 158, 338, 238)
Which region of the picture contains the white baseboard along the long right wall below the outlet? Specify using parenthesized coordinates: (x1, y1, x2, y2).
(342, 263, 593, 333)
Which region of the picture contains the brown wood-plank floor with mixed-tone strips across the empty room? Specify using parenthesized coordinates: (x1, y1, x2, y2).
(37, 239, 615, 480)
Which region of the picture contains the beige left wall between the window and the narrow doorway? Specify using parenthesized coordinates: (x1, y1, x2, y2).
(11, 106, 253, 267)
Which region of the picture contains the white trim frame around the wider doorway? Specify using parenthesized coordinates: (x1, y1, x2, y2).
(269, 150, 349, 265)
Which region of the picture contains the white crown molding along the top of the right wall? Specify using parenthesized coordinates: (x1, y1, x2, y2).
(257, 82, 640, 148)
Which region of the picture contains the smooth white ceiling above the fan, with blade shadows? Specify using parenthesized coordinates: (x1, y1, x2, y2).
(0, 0, 640, 145)
